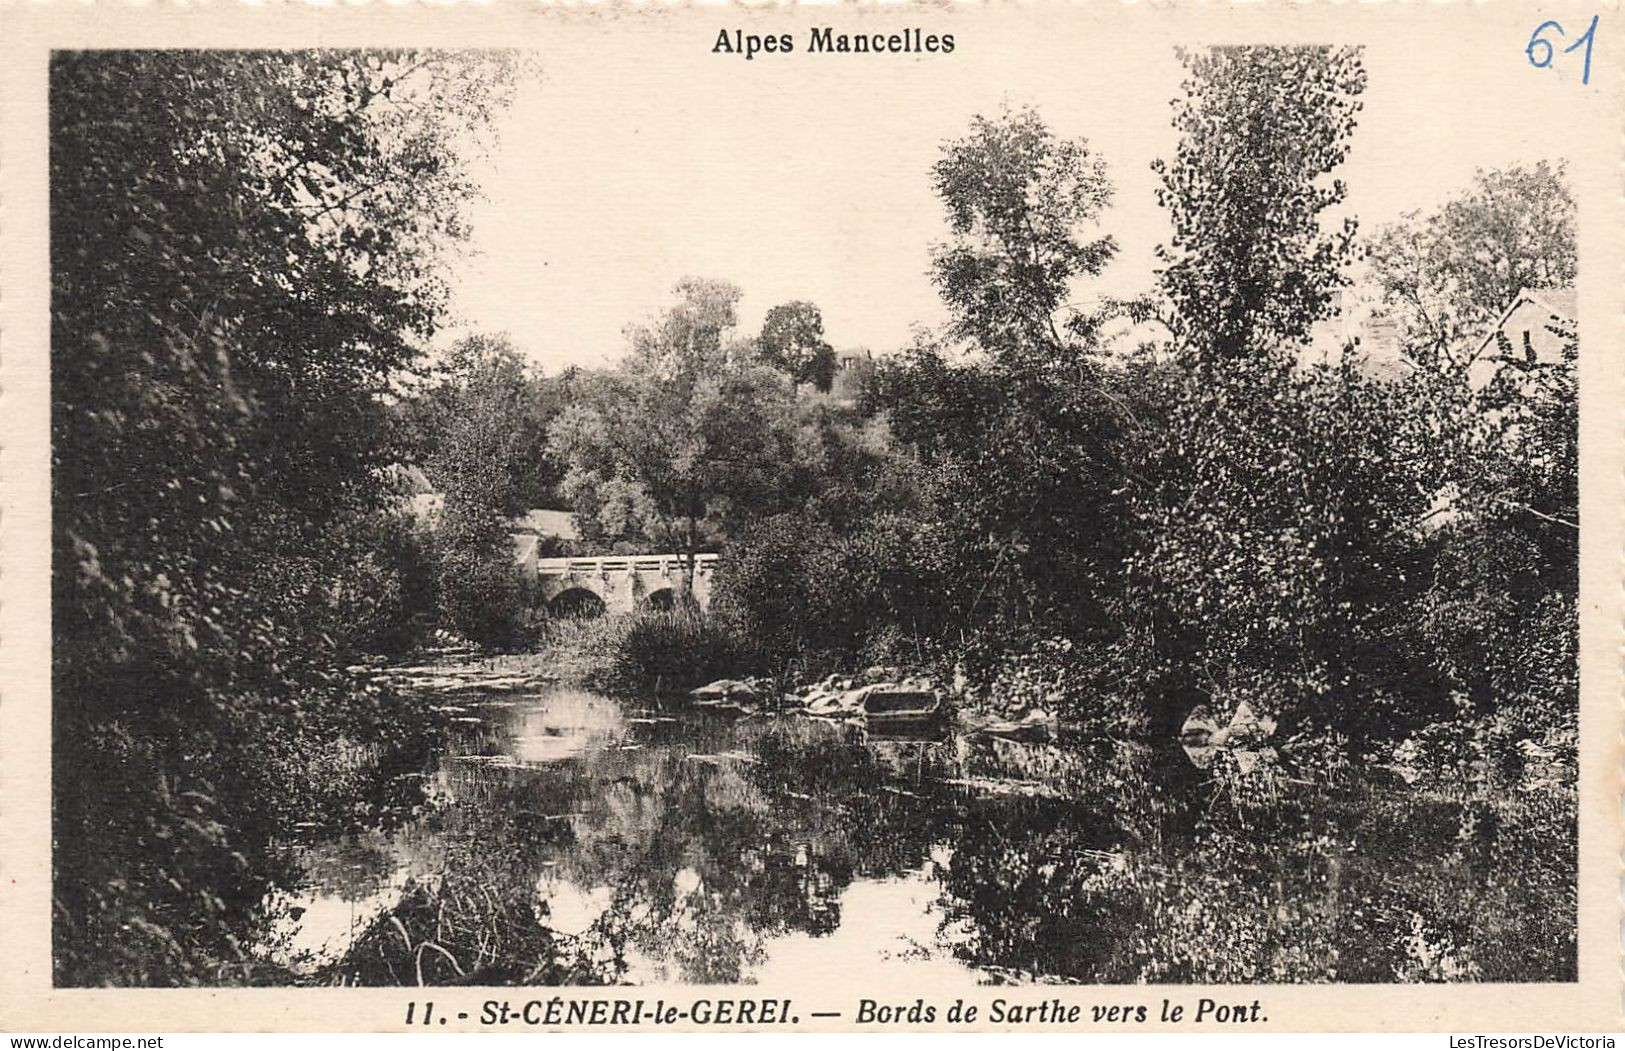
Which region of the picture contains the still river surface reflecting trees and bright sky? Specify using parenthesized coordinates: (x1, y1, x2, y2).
(273, 689, 1565, 986)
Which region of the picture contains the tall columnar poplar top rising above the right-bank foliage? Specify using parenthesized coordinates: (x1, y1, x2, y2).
(1152, 47, 1365, 364)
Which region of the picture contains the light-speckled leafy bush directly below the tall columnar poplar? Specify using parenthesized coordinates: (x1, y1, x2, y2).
(1123, 356, 1433, 736)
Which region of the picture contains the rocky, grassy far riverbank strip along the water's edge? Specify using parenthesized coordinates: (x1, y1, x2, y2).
(419, 611, 1576, 794)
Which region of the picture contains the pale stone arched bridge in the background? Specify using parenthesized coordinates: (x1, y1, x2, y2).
(517, 546, 717, 614)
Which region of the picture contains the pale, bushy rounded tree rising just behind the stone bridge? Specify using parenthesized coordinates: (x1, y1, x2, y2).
(549, 279, 793, 591)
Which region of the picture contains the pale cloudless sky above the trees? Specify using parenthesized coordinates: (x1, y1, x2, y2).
(447, 8, 1578, 372)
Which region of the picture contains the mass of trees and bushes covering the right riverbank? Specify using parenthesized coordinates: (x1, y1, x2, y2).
(698, 47, 1578, 763)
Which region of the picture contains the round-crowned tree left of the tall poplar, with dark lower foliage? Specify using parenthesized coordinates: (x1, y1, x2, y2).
(879, 109, 1129, 645)
